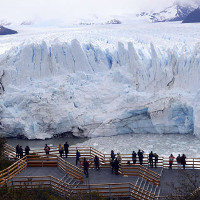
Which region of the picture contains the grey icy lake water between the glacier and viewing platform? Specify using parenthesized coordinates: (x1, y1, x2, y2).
(7, 134, 200, 158)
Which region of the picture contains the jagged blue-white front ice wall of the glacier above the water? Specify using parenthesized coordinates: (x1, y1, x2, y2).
(0, 27, 200, 139)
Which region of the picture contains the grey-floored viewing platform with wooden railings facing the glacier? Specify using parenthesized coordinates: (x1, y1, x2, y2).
(0, 144, 200, 200)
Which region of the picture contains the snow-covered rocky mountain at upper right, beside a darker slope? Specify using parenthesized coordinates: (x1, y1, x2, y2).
(138, 4, 197, 22)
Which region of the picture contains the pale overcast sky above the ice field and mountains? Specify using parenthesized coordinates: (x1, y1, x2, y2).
(0, 0, 196, 24)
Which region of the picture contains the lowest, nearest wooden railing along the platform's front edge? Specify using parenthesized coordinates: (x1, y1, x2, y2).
(7, 176, 155, 200)
